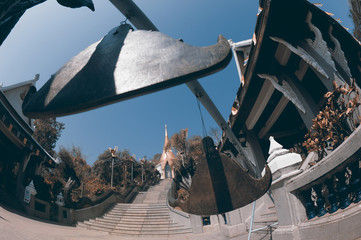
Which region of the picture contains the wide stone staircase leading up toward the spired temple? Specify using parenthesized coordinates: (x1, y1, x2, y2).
(77, 179, 192, 238)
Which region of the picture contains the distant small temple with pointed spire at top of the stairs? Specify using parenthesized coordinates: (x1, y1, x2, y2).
(156, 125, 176, 179)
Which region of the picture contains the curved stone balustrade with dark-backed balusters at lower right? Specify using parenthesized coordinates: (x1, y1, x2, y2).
(287, 124, 361, 220)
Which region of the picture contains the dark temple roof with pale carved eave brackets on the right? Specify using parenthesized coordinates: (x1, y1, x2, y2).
(219, 0, 361, 159)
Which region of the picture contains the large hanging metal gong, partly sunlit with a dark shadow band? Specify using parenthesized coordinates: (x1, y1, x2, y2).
(22, 24, 232, 118)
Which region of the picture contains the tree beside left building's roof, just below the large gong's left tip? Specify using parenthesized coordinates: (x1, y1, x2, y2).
(33, 118, 64, 156)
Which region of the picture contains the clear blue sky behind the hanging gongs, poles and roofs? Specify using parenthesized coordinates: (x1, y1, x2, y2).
(0, 0, 353, 164)
